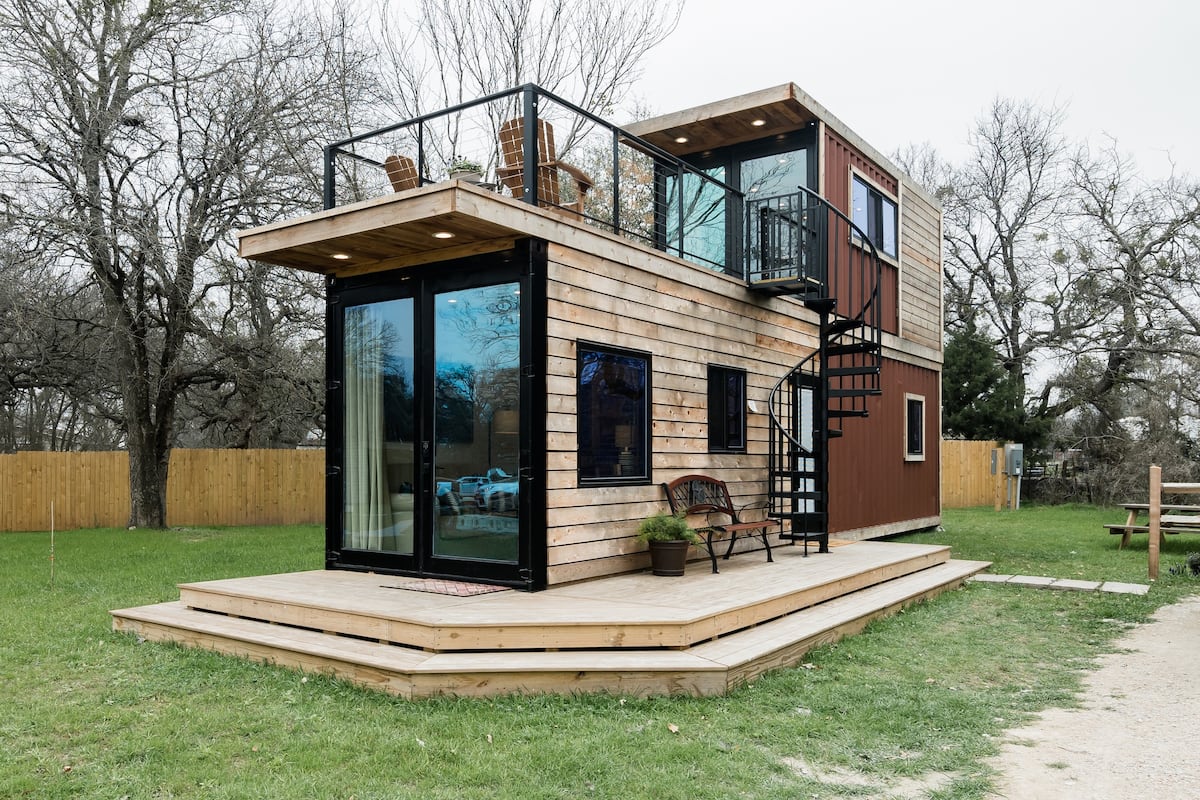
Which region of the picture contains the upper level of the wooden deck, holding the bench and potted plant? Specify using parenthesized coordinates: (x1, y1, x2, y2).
(164, 544, 950, 652)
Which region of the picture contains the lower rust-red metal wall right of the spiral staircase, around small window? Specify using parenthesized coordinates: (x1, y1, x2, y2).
(829, 360, 941, 533)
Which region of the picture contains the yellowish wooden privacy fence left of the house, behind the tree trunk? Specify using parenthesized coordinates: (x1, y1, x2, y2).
(0, 450, 325, 530)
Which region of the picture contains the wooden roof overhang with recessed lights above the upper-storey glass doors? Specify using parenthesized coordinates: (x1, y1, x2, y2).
(625, 84, 822, 156)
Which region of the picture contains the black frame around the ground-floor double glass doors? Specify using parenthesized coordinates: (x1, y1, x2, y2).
(325, 240, 546, 590)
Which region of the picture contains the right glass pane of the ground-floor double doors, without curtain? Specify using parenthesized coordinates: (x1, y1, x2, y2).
(432, 282, 521, 563)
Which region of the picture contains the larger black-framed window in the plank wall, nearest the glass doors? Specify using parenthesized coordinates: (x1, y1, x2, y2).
(576, 344, 650, 485)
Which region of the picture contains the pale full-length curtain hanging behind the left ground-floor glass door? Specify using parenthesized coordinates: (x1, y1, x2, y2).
(342, 306, 394, 551)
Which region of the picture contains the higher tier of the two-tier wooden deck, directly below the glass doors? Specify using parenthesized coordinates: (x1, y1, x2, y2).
(180, 548, 949, 652)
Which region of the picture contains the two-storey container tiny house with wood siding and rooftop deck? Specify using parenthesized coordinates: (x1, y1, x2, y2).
(240, 84, 942, 590)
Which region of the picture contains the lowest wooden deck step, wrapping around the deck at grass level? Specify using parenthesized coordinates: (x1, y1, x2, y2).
(113, 560, 988, 698)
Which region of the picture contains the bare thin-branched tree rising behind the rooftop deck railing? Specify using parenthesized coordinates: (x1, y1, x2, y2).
(378, 0, 683, 161)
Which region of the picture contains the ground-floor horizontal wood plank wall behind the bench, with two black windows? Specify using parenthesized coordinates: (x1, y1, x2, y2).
(546, 245, 816, 583)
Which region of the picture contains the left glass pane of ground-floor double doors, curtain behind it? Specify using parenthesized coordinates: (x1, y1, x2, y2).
(342, 297, 418, 554)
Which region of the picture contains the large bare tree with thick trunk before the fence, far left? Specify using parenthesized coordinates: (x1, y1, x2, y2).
(0, 0, 364, 527)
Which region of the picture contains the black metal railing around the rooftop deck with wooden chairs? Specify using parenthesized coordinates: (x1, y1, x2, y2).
(324, 84, 743, 276)
